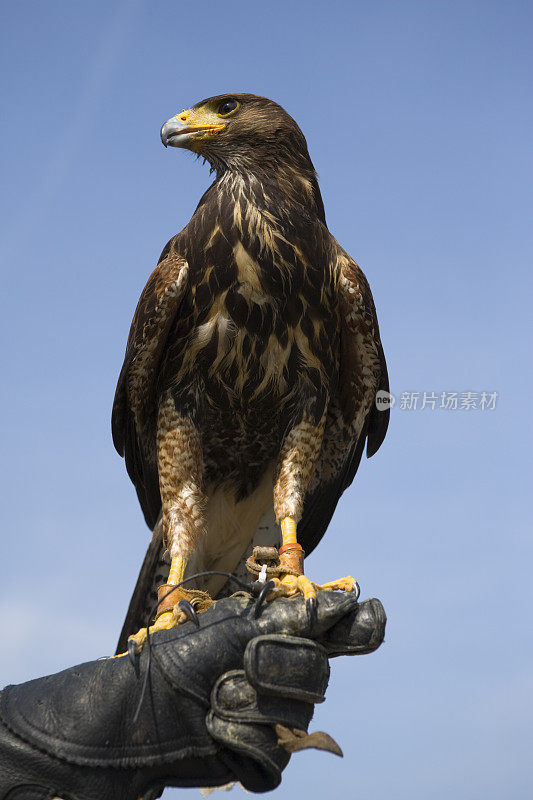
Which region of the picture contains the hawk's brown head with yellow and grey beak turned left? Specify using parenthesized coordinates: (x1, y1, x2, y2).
(161, 94, 314, 172)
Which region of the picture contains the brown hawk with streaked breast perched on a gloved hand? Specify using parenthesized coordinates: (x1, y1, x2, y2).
(112, 94, 388, 649)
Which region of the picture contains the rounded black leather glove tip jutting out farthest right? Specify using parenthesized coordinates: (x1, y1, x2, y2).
(319, 598, 387, 658)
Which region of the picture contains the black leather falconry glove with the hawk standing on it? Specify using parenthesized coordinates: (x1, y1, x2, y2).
(0, 592, 385, 800)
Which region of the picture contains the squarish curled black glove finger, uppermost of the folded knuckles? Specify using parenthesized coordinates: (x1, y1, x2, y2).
(244, 634, 329, 703)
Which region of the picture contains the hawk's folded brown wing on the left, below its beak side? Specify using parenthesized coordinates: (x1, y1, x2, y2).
(111, 253, 188, 529)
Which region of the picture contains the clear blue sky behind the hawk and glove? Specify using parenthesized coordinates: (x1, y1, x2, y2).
(0, 0, 533, 800)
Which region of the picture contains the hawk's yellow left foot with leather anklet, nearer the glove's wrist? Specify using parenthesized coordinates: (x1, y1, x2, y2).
(124, 583, 214, 655)
